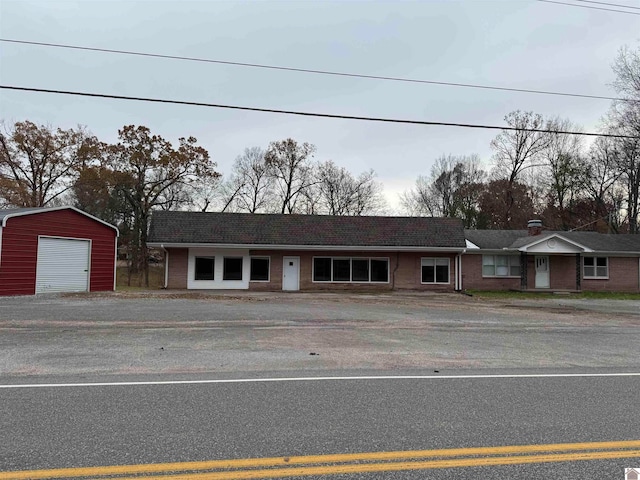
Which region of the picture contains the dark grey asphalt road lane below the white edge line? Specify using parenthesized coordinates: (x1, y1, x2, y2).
(0, 372, 640, 480)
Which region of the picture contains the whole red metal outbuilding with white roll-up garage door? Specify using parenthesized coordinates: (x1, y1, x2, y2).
(0, 207, 118, 295)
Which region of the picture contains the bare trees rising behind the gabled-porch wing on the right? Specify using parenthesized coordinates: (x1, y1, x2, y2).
(401, 47, 640, 234)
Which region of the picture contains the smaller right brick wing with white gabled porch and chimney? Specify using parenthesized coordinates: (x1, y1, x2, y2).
(462, 220, 640, 292)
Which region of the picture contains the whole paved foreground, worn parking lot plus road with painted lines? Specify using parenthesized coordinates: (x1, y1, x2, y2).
(0, 294, 640, 480)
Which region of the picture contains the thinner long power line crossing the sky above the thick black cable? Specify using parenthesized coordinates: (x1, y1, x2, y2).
(0, 38, 628, 101)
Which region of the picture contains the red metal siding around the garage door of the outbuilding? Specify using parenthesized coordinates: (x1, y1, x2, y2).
(0, 210, 116, 295)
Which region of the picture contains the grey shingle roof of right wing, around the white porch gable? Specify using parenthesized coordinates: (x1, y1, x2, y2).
(464, 230, 640, 253)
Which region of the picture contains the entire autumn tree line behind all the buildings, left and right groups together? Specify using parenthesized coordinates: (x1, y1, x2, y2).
(0, 47, 640, 284)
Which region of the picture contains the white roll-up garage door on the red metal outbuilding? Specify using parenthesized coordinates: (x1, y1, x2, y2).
(36, 237, 91, 293)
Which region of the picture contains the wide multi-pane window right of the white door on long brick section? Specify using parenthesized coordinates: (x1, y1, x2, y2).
(313, 257, 389, 283)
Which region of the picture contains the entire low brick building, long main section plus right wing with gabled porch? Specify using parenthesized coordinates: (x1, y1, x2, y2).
(148, 211, 640, 292)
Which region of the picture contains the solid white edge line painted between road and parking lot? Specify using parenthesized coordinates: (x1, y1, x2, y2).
(0, 372, 640, 389)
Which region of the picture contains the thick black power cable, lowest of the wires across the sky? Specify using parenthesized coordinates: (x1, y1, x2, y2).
(0, 85, 640, 139)
